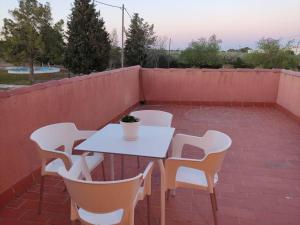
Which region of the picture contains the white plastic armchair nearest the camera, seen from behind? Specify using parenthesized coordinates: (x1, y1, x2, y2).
(59, 157, 153, 225)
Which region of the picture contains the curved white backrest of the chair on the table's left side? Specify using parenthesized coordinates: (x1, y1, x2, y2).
(30, 123, 78, 154)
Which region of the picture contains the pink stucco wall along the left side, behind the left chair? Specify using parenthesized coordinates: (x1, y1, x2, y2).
(0, 67, 140, 193)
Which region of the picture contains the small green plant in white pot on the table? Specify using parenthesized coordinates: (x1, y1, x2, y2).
(120, 115, 140, 141)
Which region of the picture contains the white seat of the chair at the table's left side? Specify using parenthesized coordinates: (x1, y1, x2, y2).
(45, 154, 103, 174)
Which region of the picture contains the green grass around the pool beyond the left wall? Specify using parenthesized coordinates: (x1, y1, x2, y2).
(0, 70, 68, 85)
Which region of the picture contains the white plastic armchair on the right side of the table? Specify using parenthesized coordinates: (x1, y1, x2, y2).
(165, 130, 232, 225)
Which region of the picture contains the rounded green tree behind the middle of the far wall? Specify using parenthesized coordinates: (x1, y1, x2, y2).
(179, 35, 222, 68)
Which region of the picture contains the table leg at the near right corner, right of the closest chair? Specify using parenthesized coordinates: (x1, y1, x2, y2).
(157, 159, 166, 225)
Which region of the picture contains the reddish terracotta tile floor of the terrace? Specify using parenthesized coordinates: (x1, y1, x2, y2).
(0, 105, 300, 225)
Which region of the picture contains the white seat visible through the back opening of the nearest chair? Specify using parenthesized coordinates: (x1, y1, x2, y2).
(78, 209, 124, 225)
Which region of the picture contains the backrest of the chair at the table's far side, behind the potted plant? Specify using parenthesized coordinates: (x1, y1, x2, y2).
(130, 110, 173, 127)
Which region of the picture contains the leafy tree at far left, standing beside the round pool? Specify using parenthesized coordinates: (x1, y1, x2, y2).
(2, 0, 51, 83)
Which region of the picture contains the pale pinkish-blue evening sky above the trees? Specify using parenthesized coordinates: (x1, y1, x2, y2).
(0, 0, 300, 50)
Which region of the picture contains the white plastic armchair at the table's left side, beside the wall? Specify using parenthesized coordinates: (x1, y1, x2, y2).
(30, 123, 105, 214)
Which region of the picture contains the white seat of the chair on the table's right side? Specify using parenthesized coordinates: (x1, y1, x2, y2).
(176, 167, 218, 188)
